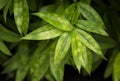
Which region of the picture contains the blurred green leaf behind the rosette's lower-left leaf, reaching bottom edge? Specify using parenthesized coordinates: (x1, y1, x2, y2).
(50, 41, 65, 81)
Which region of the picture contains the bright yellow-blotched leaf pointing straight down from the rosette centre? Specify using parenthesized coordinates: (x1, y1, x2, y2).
(71, 30, 82, 72)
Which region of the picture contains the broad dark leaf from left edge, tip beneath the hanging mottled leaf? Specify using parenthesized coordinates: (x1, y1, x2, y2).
(0, 24, 20, 42)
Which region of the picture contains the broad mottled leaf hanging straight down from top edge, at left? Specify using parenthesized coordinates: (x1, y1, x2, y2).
(14, 0, 29, 34)
